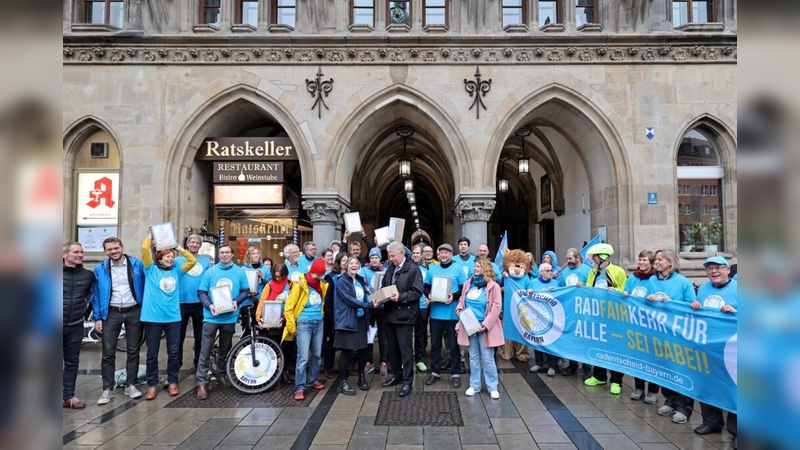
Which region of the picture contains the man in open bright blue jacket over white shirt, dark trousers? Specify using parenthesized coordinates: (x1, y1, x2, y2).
(92, 237, 144, 405)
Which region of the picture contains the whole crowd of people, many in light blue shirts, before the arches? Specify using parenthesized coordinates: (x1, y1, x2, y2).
(64, 231, 737, 444)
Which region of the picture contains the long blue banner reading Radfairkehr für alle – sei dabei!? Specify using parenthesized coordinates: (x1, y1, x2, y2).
(503, 283, 737, 412)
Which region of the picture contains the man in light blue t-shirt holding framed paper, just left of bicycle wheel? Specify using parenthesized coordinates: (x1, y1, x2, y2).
(195, 245, 250, 400)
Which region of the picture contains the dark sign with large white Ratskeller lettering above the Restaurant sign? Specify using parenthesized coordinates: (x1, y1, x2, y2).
(197, 137, 297, 161)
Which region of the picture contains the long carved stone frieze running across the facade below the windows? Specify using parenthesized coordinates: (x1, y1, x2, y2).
(62, 40, 736, 65)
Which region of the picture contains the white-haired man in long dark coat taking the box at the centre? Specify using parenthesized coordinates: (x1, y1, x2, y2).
(382, 241, 422, 397)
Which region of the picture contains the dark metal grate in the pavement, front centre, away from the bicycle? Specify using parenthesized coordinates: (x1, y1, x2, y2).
(375, 391, 464, 427)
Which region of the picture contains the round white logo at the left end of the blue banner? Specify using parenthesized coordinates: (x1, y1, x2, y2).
(511, 290, 565, 345)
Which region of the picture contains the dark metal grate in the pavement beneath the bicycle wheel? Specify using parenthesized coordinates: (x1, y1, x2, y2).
(166, 383, 318, 408)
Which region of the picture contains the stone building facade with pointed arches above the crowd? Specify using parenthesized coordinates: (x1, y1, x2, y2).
(63, 0, 737, 264)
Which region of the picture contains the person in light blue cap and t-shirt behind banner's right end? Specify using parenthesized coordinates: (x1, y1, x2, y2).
(691, 256, 739, 438)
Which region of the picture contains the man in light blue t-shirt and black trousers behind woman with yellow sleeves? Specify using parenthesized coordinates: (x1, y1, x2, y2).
(175, 234, 212, 370)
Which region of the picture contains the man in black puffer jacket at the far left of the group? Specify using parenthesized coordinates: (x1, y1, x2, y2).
(62, 242, 95, 409)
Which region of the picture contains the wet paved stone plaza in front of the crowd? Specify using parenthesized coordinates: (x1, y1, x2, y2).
(63, 338, 733, 450)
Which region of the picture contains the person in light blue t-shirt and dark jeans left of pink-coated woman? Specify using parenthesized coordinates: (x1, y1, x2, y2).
(423, 244, 466, 389)
